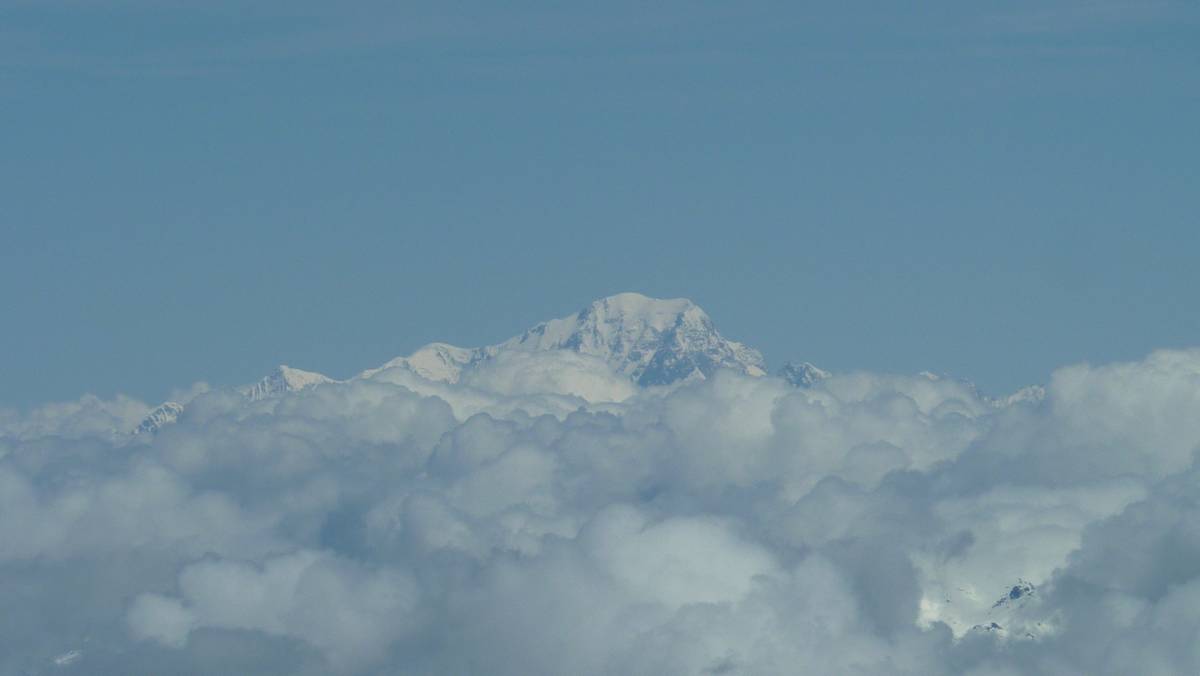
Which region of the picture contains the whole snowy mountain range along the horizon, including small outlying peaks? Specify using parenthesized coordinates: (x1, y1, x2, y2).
(119, 293, 1044, 441)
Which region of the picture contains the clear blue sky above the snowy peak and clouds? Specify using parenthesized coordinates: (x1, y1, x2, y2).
(0, 0, 1200, 406)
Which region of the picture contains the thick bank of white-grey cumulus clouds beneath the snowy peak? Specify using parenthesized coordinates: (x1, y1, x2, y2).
(0, 351, 1200, 676)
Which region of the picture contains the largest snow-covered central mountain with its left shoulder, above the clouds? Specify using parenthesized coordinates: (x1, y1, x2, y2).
(360, 293, 766, 387)
